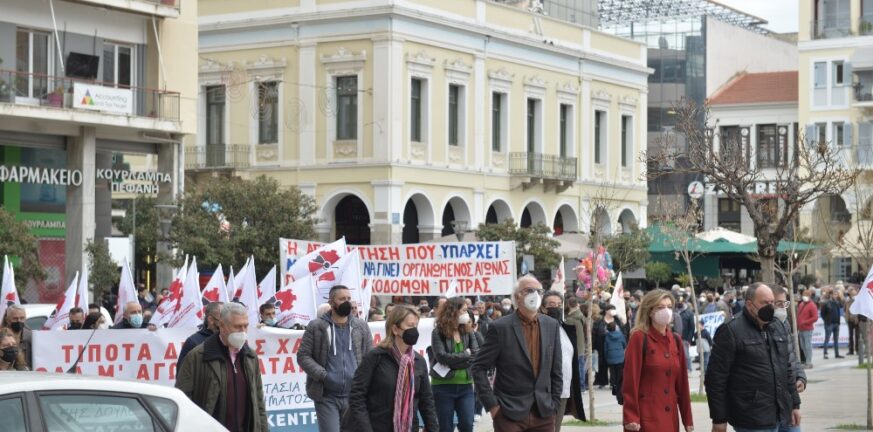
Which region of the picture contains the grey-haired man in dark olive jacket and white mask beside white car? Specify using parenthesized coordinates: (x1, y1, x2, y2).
(176, 303, 269, 432)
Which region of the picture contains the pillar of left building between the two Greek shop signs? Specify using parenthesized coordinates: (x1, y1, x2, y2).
(64, 127, 97, 285)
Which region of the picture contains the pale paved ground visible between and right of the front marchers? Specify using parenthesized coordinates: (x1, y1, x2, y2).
(474, 350, 867, 432)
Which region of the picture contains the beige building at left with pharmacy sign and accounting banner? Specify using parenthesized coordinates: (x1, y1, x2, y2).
(0, 0, 197, 302)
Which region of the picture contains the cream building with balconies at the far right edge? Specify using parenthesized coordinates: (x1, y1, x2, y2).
(798, 0, 873, 281)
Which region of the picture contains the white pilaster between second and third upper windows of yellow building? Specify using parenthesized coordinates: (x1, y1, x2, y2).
(297, 42, 319, 166)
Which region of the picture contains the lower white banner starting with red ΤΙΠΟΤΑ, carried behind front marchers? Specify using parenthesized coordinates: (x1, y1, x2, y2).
(33, 318, 434, 432)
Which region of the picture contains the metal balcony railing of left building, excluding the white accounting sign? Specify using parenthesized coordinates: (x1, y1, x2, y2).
(0, 69, 179, 120)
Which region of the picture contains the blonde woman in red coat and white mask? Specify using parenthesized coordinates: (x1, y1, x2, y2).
(622, 289, 694, 432)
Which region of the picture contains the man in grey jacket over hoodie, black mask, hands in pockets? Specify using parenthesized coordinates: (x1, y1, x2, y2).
(297, 285, 373, 432)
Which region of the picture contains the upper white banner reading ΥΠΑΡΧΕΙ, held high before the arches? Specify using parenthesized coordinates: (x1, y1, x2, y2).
(279, 239, 516, 296)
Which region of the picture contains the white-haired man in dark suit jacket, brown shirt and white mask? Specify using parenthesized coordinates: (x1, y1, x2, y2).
(471, 276, 563, 432)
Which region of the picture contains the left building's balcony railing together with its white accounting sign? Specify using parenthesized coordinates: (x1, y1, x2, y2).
(0, 69, 179, 120)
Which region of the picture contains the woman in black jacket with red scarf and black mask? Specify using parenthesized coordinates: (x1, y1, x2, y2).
(342, 305, 439, 432)
